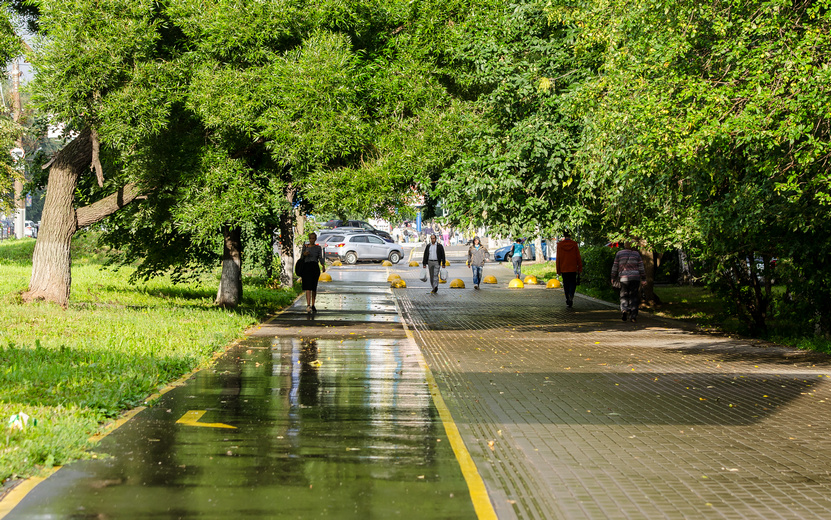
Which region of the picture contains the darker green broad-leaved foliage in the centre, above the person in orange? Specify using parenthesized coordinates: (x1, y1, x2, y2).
(436, 1, 590, 237)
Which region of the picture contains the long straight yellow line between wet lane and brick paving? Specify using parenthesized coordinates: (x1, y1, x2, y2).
(399, 322, 497, 520)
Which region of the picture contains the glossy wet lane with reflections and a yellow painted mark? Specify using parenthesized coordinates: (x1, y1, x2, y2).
(7, 272, 475, 519)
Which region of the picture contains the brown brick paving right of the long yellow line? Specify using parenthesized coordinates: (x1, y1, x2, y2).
(394, 278, 831, 519)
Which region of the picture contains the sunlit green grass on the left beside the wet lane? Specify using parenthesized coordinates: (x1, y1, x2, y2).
(0, 237, 297, 482)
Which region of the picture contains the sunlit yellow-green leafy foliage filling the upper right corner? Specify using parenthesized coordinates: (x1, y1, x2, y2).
(550, 0, 831, 331)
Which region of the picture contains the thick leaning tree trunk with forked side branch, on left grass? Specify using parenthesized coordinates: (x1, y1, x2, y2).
(23, 130, 145, 307)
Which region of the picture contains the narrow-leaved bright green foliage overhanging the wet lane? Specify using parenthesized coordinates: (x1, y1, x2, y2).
(91, 1, 459, 300)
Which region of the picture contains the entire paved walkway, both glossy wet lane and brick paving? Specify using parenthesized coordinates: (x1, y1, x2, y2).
(4, 263, 831, 520)
